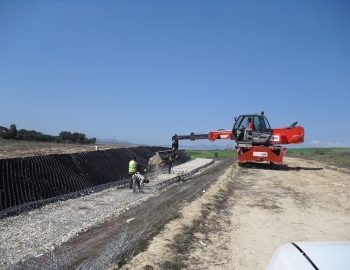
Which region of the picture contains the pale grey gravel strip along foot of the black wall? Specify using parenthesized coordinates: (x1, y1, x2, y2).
(0, 159, 212, 269)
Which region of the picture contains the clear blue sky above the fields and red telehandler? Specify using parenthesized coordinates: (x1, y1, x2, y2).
(0, 0, 350, 147)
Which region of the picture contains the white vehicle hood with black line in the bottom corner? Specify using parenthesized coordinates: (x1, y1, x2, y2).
(266, 241, 350, 270)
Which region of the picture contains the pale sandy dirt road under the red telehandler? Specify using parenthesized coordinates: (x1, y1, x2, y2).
(121, 158, 350, 269)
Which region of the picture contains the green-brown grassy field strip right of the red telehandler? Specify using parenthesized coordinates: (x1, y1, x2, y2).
(285, 148, 350, 166)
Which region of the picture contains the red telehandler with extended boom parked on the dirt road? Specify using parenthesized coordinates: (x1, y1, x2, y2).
(172, 111, 305, 164)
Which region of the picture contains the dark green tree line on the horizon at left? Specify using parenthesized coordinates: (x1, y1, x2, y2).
(0, 124, 96, 144)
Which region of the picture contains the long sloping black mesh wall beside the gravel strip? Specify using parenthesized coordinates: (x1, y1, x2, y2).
(0, 146, 190, 218)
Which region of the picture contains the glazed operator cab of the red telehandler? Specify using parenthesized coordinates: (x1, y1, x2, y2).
(232, 114, 272, 145)
